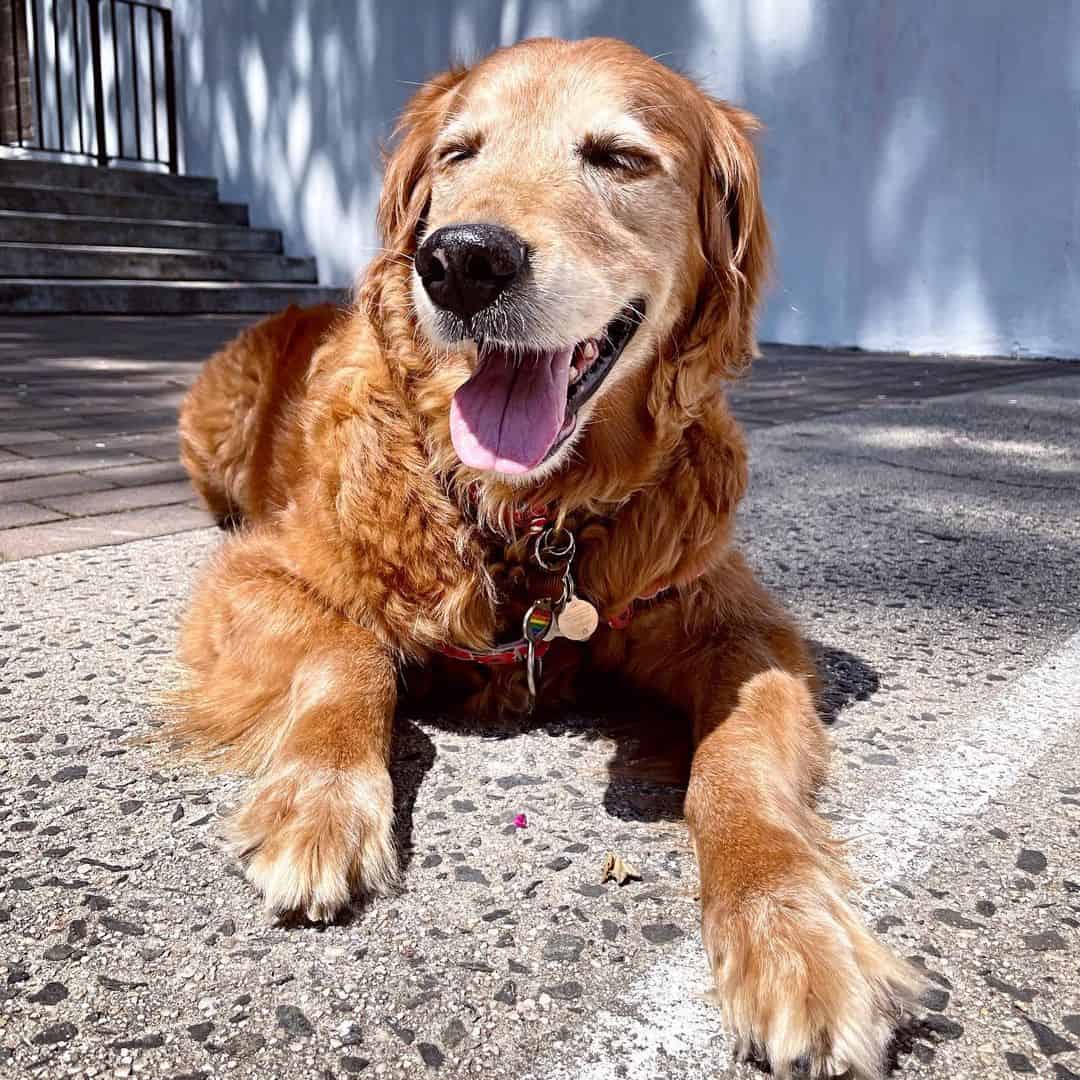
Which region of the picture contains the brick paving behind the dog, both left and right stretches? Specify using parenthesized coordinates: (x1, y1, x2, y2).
(0, 316, 1068, 561)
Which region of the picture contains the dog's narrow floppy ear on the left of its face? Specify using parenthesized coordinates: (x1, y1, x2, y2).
(378, 67, 468, 255)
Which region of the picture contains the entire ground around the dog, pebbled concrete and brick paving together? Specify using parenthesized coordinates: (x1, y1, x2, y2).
(0, 320, 1080, 1080)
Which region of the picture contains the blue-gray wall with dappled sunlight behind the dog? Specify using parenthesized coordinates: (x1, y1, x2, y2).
(174, 0, 1080, 356)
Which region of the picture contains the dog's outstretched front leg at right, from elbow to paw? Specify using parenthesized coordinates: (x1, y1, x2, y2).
(687, 661, 917, 1080)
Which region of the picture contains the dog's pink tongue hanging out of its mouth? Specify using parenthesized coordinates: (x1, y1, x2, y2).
(450, 348, 573, 473)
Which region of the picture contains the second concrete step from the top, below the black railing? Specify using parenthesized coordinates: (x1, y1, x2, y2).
(0, 184, 247, 225)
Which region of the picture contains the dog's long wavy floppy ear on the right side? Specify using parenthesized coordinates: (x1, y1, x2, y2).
(675, 98, 771, 411)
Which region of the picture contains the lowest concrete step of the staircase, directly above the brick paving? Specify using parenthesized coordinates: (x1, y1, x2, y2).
(0, 278, 348, 315)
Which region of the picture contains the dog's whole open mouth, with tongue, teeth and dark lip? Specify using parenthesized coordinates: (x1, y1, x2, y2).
(450, 300, 645, 474)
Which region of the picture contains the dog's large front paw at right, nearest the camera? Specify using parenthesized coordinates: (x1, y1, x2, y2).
(702, 866, 920, 1080)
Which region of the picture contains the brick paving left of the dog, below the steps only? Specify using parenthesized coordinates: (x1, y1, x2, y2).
(0, 316, 247, 559)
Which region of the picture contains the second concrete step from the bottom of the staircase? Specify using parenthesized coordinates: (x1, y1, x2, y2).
(0, 243, 319, 285)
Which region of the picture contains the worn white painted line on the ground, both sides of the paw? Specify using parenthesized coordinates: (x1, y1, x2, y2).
(532, 633, 1080, 1080)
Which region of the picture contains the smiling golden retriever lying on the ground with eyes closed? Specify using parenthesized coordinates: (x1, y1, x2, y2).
(171, 39, 917, 1077)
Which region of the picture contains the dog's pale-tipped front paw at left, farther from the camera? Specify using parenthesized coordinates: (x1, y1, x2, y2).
(231, 765, 397, 921)
